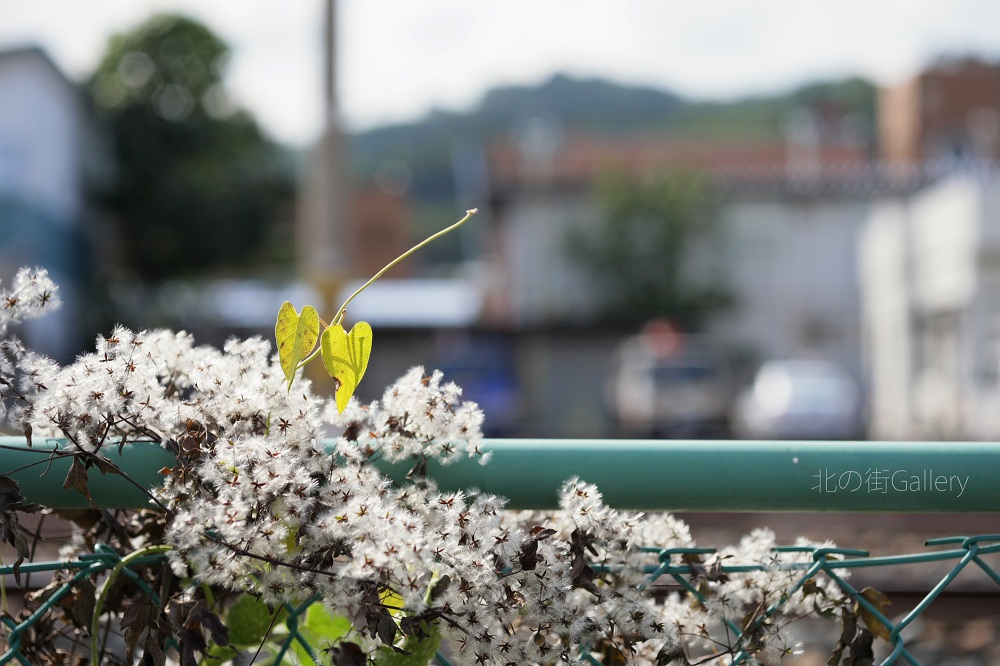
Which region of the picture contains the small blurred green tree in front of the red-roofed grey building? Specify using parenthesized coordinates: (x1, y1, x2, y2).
(569, 172, 731, 331)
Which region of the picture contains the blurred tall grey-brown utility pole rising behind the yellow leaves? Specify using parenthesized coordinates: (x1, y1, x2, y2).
(297, 0, 353, 309)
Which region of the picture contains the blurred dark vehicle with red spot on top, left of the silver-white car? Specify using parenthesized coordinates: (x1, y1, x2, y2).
(608, 323, 730, 438)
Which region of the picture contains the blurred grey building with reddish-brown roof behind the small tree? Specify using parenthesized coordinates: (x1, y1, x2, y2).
(488, 109, 888, 378)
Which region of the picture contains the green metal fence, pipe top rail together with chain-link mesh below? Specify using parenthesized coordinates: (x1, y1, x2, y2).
(0, 438, 1000, 666)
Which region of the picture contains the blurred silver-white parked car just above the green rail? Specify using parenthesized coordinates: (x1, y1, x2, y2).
(733, 360, 864, 439)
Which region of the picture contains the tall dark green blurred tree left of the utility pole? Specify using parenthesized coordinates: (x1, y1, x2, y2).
(88, 15, 293, 280)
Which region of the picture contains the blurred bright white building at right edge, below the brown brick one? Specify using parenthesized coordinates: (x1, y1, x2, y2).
(859, 174, 1000, 439)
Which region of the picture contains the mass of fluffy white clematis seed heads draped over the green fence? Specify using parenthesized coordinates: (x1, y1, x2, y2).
(0, 271, 835, 664)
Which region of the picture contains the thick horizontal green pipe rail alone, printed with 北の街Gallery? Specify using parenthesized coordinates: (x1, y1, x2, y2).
(0, 437, 1000, 513)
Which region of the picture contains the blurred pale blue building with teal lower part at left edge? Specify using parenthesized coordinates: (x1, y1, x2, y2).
(0, 47, 112, 358)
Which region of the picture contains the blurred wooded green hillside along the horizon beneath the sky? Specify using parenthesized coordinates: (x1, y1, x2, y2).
(352, 75, 875, 246)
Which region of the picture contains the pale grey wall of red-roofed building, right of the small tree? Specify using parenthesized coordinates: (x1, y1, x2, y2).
(714, 199, 868, 378)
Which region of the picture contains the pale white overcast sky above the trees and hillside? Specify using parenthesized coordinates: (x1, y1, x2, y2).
(0, 0, 1000, 144)
